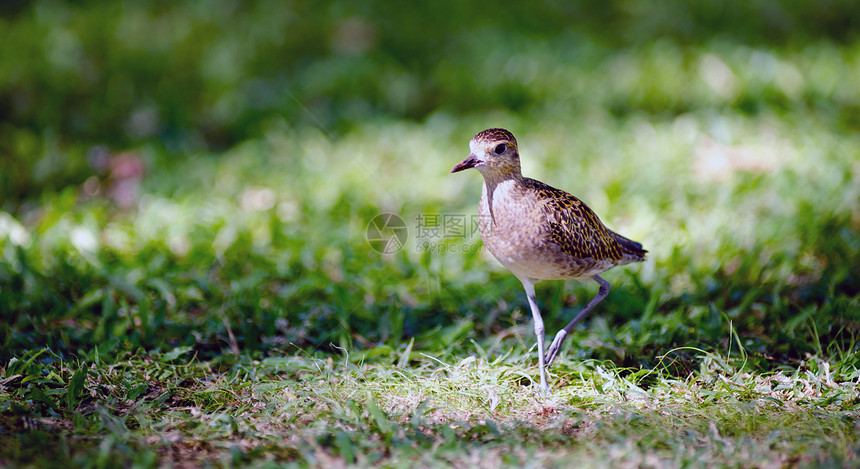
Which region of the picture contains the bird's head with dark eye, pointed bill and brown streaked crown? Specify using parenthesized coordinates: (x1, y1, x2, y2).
(451, 129, 520, 179)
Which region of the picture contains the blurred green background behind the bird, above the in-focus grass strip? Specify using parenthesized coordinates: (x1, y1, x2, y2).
(0, 0, 860, 369)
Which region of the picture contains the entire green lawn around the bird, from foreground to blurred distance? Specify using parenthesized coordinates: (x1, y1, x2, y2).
(0, 2, 860, 467)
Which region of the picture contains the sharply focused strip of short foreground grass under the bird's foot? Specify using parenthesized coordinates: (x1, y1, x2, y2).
(3, 344, 860, 467)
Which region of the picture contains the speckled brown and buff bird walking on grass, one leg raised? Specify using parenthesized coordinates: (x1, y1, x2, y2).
(451, 128, 647, 394)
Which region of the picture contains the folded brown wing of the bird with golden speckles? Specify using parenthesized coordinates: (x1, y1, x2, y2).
(527, 179, 623, 261)
